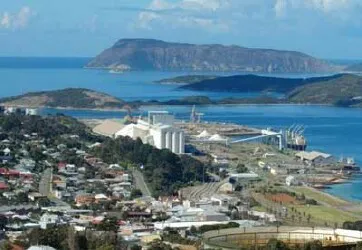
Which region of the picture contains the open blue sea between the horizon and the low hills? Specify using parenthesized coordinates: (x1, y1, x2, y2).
(0, 57, 332, 101)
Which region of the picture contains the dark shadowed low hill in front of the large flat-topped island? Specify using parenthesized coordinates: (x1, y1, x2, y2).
(180, 75, 340, 93)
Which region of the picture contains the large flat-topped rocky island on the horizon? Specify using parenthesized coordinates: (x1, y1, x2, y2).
(86, 39, 333, 73)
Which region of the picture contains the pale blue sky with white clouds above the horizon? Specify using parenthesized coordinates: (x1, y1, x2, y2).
(0, 0, 362, 60)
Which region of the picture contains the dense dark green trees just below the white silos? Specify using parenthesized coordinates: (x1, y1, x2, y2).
(94, 137, 204, 197)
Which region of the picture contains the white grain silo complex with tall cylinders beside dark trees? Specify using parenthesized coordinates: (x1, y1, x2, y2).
(115, 111, 185, 154)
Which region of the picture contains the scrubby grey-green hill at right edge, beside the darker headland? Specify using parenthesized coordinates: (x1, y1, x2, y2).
(288, 74, 362, 107)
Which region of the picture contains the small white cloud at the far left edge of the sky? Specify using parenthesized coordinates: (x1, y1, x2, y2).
(0, 6, 36, 30)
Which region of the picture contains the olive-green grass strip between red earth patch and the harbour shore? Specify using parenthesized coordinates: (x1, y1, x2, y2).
(289, 187, 349, 207)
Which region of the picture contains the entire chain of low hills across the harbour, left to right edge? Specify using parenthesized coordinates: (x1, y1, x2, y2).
(0, 74, 362, 110)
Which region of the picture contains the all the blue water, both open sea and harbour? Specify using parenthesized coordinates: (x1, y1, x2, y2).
(0, 58, 362, 202)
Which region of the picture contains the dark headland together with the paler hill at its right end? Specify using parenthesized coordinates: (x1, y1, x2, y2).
(180, 74, 362, 106)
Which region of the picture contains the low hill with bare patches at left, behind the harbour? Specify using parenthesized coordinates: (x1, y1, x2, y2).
(0, 88, 125, 109)
